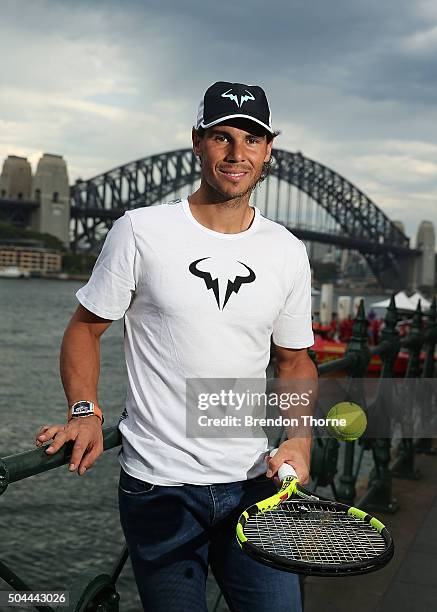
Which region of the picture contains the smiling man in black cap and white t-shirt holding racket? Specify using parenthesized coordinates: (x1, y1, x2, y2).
(38, 82, 317, 612)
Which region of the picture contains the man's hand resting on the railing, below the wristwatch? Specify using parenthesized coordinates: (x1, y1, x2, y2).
(35, 415, 103, 476)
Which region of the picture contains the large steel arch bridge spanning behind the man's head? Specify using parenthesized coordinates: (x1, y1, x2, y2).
(71, 149, 418, 287)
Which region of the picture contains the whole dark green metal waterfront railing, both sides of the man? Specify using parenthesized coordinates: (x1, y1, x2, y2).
(0, 297, 437, 612)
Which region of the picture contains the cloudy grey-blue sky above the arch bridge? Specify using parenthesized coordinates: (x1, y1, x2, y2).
(0, 0, 437, 236)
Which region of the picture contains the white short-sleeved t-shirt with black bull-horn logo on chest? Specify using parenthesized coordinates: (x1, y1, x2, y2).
(76, 199, 314, 485)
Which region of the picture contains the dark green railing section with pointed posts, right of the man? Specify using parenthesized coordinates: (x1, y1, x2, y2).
(311, 296, 437, 512)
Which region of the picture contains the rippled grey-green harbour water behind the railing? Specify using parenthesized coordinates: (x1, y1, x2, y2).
(0, 279, 384, 612)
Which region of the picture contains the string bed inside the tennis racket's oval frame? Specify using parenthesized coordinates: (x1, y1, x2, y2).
(244, 502, 386, 565)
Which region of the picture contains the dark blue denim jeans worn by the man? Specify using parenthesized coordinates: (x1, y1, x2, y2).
(118, 468, 302, 612)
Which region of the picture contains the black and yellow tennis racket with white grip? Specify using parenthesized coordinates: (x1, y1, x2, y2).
(237, 449, 394, 576)
